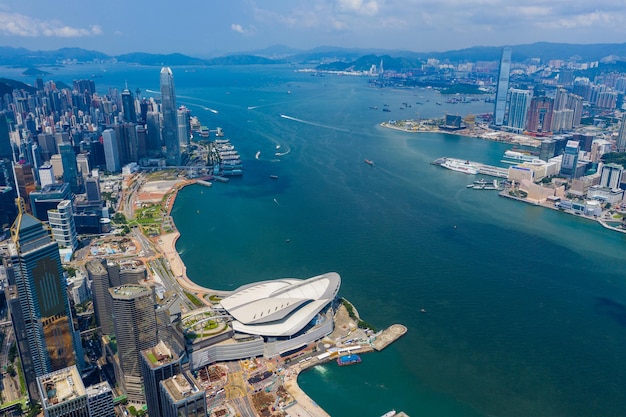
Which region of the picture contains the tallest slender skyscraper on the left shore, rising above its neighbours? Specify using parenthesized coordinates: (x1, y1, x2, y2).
(161, 67, 180, 165)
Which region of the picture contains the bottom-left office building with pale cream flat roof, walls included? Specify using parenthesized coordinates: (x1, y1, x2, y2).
(37, 366, 90, 417)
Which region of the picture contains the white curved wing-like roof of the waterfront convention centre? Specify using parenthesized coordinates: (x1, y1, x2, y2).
(220, 272, 341, 336)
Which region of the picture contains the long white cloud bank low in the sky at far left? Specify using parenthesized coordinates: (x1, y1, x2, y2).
(0, 12, 103, 38)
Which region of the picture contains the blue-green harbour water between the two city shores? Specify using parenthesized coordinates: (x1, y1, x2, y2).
(33, 66, 626, 417)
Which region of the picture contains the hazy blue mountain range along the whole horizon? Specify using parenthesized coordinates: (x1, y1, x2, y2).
(0, 42, 626, 69)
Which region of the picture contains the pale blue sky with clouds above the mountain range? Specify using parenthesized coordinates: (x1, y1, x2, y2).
(0, 0, 626, 58)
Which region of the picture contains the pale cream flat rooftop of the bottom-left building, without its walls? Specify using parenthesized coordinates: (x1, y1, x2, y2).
(37, 366, 87, 408)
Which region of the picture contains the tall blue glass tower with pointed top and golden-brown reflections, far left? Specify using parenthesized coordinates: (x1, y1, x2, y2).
(8, 206, 82, 393)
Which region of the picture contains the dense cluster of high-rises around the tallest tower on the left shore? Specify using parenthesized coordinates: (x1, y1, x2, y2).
(0, 67, 191, 250)
